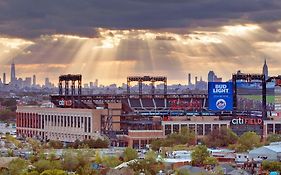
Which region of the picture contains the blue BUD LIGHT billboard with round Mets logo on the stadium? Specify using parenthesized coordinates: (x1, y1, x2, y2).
(208, 82, 233, 111)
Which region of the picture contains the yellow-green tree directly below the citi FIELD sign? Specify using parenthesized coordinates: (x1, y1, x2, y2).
(238, 132, 261, 152)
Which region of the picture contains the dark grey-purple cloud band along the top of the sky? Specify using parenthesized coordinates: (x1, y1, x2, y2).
(0, 0, 281, 38)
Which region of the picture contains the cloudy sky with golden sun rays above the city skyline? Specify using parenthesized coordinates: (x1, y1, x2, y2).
(0, 0, 281, 84)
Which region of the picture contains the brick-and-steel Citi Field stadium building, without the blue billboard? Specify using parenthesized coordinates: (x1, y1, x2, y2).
(17, 75, 281, 148)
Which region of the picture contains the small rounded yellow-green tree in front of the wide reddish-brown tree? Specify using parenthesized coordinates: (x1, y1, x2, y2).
(191, 145, 210, 166)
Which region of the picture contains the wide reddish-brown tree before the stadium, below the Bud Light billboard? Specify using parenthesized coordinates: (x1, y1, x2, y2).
(204, 127, 238, 147)
